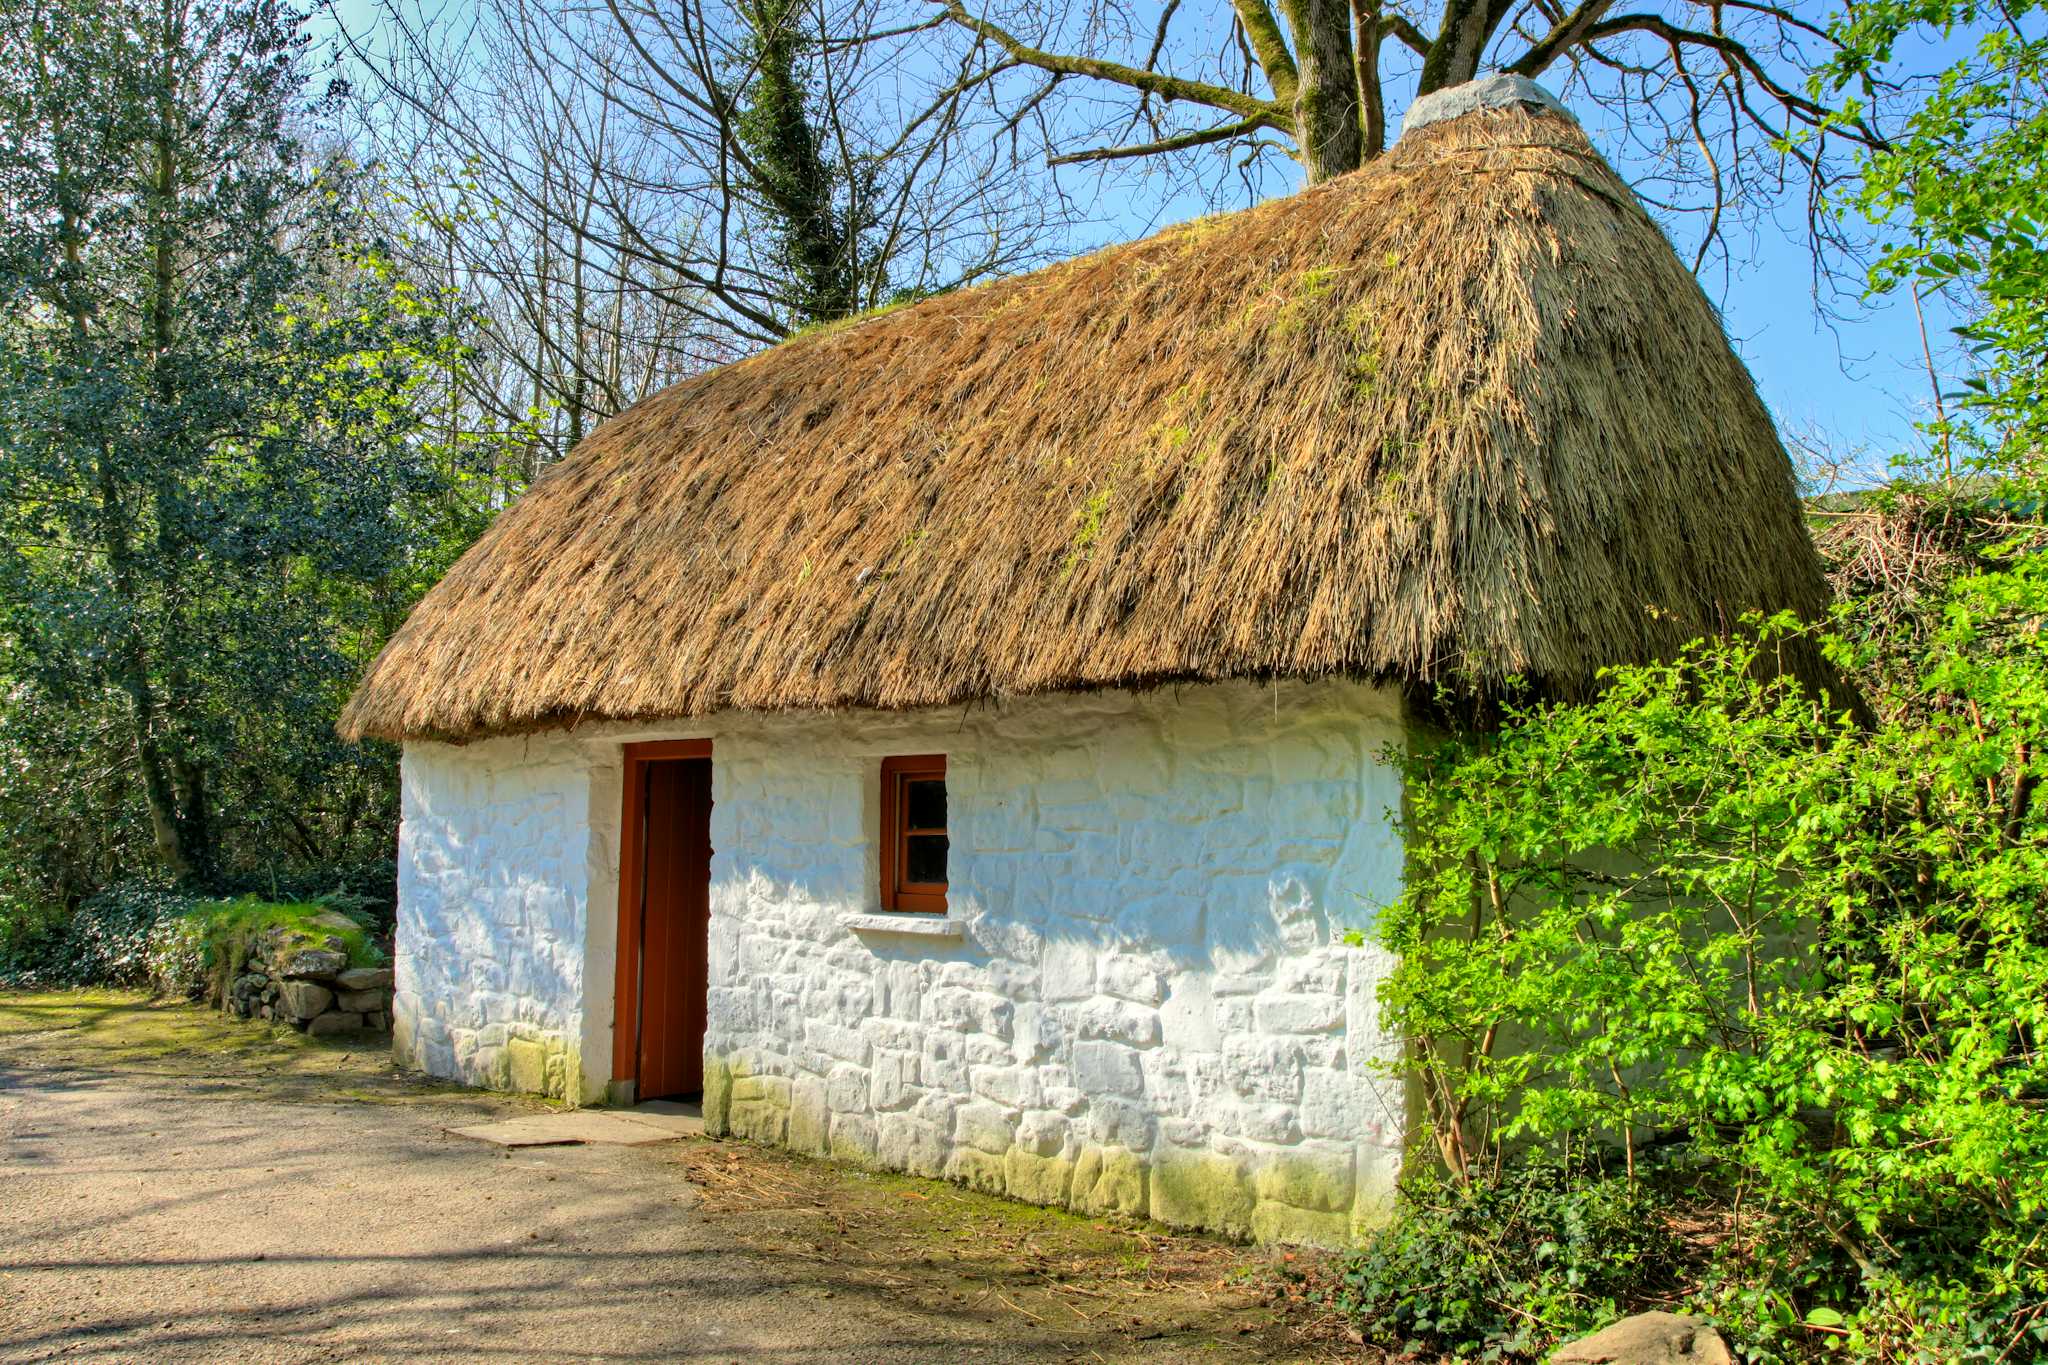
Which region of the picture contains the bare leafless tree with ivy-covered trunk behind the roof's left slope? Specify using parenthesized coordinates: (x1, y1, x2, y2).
(346, 0, 1065, 469)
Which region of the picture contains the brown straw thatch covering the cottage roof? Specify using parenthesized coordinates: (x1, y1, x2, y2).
(342, 108, 1825, 737)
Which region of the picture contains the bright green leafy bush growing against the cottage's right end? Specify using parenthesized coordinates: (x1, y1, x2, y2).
(1358, 553, 2048, 1361)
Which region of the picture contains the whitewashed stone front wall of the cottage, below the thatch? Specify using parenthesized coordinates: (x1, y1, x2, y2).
(397, 681, 1403, 1242)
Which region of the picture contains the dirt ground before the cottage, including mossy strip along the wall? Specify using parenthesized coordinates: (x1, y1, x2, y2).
(0, 999, 1325, 1361)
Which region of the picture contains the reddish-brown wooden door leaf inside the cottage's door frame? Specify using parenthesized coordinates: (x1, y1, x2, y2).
(637, 759, 711, 1099)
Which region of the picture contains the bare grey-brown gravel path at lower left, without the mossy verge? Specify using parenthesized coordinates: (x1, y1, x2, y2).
(0, 1031, 1327, 1361)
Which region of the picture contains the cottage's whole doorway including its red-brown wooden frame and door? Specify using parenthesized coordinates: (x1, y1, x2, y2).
(612, 739, 711, 1103)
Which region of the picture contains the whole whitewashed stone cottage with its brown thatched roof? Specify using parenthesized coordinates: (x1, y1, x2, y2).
(342, 82, 1823, 1242)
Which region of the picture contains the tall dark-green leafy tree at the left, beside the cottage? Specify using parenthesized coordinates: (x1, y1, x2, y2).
(0, 0, 464, 882)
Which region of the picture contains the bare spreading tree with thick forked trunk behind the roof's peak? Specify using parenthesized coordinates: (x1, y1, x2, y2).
(930, 0, 1876, 250)
